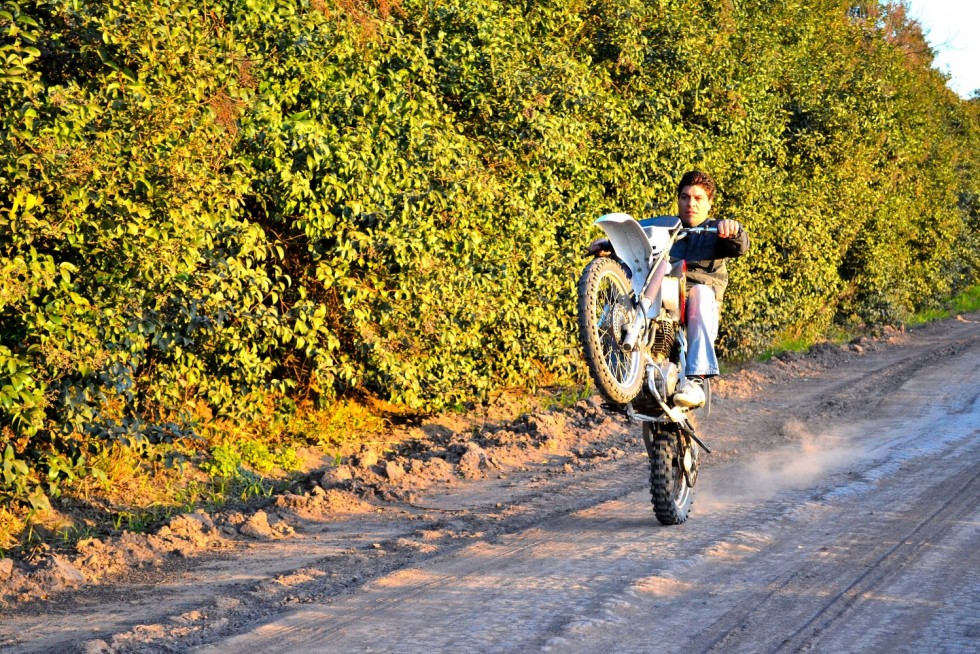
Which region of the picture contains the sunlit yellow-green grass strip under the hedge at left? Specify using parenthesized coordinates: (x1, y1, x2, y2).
(0, 401, 387, 557)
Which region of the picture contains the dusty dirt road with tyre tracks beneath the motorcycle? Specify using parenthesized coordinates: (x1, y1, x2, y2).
(0, 314, 980, 653)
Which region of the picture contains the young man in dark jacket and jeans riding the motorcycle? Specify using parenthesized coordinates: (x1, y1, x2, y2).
(589, 170, 749, 407)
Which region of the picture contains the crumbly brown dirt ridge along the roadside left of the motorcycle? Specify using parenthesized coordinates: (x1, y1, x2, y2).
(0, 398, 617, 606)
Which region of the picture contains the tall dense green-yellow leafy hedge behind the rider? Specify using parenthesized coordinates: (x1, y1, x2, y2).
(0, 0, 980, 508)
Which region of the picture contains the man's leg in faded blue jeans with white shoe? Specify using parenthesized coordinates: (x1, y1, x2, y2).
(674, 284, 718, 407)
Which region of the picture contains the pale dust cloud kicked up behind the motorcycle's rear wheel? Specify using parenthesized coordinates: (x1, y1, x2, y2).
(695, 422, 867, 513)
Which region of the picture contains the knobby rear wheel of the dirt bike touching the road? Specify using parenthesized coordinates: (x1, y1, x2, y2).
(643, 422, 698, 525)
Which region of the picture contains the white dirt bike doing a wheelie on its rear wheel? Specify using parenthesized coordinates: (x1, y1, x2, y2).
(578, 213, 717, 525)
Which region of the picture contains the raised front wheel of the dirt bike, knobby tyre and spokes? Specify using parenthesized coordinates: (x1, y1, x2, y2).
(578, 257, 643, 404)
